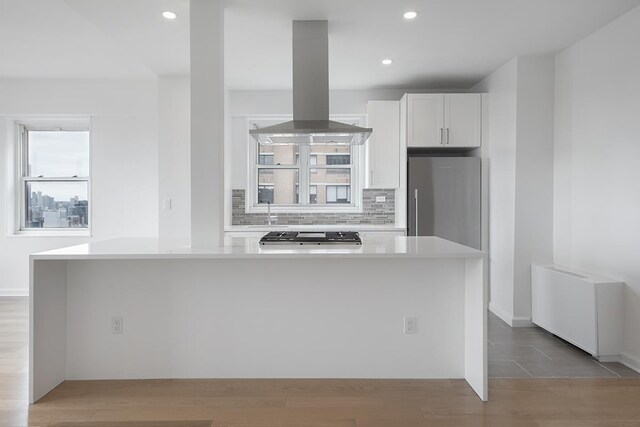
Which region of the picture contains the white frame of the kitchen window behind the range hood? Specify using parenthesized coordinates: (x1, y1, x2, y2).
(245, 115, 365, 213)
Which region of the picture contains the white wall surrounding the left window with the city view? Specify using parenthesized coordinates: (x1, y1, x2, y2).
(0, 79, 158, 295)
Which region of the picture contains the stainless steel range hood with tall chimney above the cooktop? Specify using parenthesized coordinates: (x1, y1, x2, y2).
(249, 21, 373, 145)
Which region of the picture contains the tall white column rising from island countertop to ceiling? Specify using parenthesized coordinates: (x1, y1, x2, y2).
(190, 0, 224, 247)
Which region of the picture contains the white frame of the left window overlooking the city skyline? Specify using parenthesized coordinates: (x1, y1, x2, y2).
(13, 118, 93, 237)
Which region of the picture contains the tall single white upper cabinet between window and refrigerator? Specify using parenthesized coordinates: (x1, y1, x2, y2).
(365, 101, 400, 188)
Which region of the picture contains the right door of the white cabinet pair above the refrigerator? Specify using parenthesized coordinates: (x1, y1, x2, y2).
(444, 93, 482, 147)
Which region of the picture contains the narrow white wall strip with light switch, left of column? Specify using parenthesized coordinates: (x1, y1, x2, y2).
(158, 77, 191, 239)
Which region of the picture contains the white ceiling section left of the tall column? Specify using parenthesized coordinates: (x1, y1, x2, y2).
(0, 0, 189, 78)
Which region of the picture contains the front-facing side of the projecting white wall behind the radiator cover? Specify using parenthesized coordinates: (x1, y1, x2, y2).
(513, 55, 554, 325)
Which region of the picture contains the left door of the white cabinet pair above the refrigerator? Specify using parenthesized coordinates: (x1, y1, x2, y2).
(407, 93, 444, 147)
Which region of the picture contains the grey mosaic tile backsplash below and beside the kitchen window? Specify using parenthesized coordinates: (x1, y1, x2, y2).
(232, 189, 396, 225)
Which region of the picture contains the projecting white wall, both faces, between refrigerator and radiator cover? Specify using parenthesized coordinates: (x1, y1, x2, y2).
(473, 56, 554, 326)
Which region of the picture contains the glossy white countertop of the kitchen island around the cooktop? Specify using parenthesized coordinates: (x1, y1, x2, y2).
(31, 236, 484, 260)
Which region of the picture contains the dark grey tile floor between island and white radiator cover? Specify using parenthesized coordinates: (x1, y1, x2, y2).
(488, 312, 640, 378)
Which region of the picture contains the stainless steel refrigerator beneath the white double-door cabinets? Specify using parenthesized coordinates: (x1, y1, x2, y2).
(407, 156, 481, 249)
